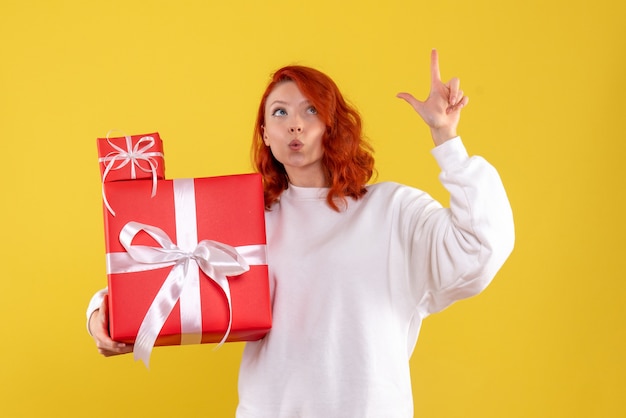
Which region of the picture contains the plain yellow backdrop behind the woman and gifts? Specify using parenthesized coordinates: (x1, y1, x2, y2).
(0, 0, 626, 418)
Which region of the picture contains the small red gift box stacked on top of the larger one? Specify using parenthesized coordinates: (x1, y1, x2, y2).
(97, 132, 165, 183)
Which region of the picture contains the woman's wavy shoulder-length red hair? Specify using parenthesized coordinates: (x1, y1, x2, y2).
(252, 66, 374, 211)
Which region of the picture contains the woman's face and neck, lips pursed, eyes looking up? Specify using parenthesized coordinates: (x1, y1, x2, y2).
(263, 81, 326, 187)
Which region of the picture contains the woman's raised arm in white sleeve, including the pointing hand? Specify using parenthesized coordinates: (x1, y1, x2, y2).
(398, 50, 515, 313)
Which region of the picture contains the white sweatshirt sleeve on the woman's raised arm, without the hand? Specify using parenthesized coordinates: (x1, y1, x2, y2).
(407, 137, 515, 314)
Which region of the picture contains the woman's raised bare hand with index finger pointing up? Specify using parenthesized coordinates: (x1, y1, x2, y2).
(398, 49, 469, 145)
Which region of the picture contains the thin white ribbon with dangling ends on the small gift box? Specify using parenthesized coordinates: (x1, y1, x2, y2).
(98, 132, 163, 216)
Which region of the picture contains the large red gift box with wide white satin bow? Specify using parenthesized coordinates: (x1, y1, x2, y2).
(104, 174, 271, 364)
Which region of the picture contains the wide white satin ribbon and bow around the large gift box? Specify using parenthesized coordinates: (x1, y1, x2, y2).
(107, 179, 267, 367)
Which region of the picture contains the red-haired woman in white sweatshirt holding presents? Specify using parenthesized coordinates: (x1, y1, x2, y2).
(87, 51, 514, 418)
